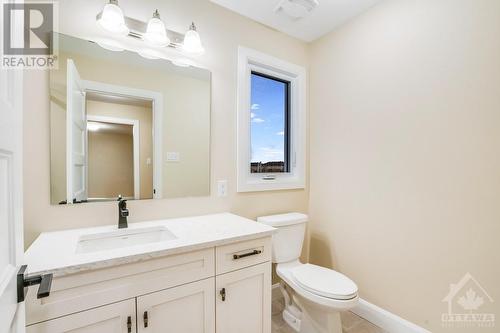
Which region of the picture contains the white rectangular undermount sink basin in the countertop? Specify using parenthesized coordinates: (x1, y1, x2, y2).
(76, 226, 177, 253)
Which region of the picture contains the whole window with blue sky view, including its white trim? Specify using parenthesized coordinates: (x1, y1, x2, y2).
(238, 47, 306, 192)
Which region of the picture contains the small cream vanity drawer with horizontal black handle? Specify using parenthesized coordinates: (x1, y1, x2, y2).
(215, 237, 271, 274)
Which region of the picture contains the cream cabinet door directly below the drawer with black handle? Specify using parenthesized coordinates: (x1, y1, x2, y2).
(216, 262, 271, 333)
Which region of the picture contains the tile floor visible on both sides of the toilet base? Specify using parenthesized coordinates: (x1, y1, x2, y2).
(272, 298, 385, 333)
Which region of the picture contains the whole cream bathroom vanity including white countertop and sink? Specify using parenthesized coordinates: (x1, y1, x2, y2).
(26, 213, 274, 333)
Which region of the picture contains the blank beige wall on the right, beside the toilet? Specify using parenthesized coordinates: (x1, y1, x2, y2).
(310, 0, 500, 332)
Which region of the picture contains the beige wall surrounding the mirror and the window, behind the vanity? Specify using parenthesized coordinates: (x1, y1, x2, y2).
(24, 0, 308, 245)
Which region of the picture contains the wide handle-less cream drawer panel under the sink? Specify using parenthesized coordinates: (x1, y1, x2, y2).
(26, 248, 215, 325)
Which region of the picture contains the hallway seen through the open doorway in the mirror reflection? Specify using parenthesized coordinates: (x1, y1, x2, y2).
(86, 92, 153, 201)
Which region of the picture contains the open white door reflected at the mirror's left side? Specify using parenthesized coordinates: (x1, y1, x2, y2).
(66, 59, 88, 203)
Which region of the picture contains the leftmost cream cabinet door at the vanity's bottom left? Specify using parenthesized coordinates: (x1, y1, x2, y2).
(26, 299, 136, 333)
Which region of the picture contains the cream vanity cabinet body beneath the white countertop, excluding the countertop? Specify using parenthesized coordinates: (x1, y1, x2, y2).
(26, 236, 271, 333)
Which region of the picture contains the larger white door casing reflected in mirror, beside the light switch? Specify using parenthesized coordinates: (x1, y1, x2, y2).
(83, 80, 163, 199)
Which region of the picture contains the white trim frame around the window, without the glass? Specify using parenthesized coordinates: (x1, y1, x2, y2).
(237, 46, 307, 192)
